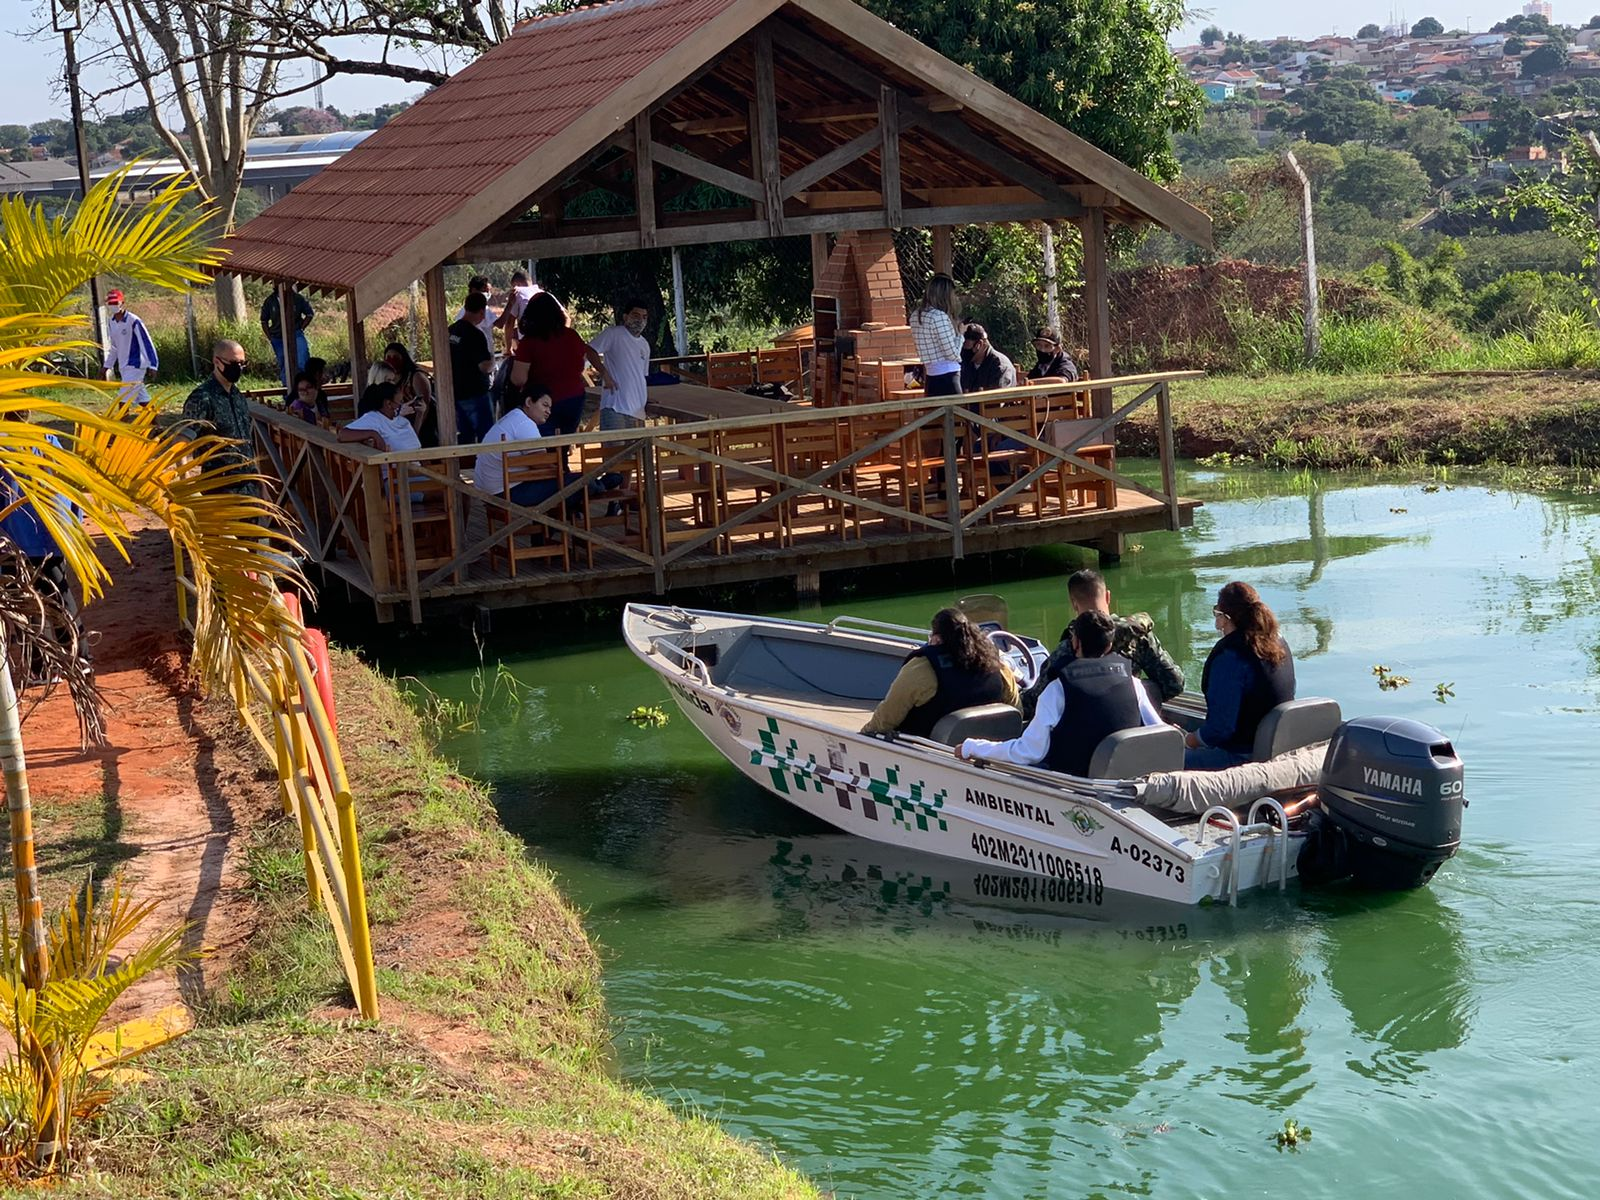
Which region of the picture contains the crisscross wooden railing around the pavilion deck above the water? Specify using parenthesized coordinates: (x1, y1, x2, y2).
(253, 371, 1202, 621)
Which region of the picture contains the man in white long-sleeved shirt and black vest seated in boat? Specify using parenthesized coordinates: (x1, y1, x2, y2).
(955, 610, 1162, 774)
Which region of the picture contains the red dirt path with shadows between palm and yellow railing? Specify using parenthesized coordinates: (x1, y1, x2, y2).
(22, 530, 280, 1018)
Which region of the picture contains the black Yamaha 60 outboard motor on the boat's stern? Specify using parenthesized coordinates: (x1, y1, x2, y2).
(1298, 717, 1467, 891)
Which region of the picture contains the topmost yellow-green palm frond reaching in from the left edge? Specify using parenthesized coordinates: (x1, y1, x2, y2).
(0, 168, 224, 356)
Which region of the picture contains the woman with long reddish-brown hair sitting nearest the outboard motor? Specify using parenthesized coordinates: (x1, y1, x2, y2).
(1184, 582, 1294, 771)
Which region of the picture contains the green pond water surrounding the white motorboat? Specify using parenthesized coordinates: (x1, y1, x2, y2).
(381, 470, 1600, 1200)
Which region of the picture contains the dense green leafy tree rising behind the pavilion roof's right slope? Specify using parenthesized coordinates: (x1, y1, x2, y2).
(866, 0, 1205, 179)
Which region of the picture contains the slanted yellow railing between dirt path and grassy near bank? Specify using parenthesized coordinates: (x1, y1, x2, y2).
(174, 550, 378, 1019)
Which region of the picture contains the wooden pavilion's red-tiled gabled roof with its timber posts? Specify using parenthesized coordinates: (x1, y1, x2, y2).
(216, 0, 1211, 616)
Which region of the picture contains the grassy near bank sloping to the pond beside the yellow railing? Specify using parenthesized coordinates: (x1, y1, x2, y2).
(66, 654, 816, 1200)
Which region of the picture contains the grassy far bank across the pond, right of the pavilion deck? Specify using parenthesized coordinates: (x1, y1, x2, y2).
(1118, 371, 1600, 467)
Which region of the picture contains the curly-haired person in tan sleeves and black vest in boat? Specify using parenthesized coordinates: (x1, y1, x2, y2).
(861, 608, 1018, 738)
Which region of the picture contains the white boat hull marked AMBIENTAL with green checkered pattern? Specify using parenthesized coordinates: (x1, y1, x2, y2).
(629, 605, 1298, 904)
